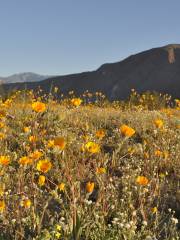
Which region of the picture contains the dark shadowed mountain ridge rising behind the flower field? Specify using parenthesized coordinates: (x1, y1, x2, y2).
(3, 44, 180, 100)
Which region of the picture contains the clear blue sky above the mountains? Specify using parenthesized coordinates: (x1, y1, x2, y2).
(0, 0, 180, 76)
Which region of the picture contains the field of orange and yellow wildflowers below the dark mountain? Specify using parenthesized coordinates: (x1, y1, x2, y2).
(0, 89, 180, 240)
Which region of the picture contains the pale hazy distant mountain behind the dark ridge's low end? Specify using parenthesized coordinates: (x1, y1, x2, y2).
(0, 72, 50, 84)
